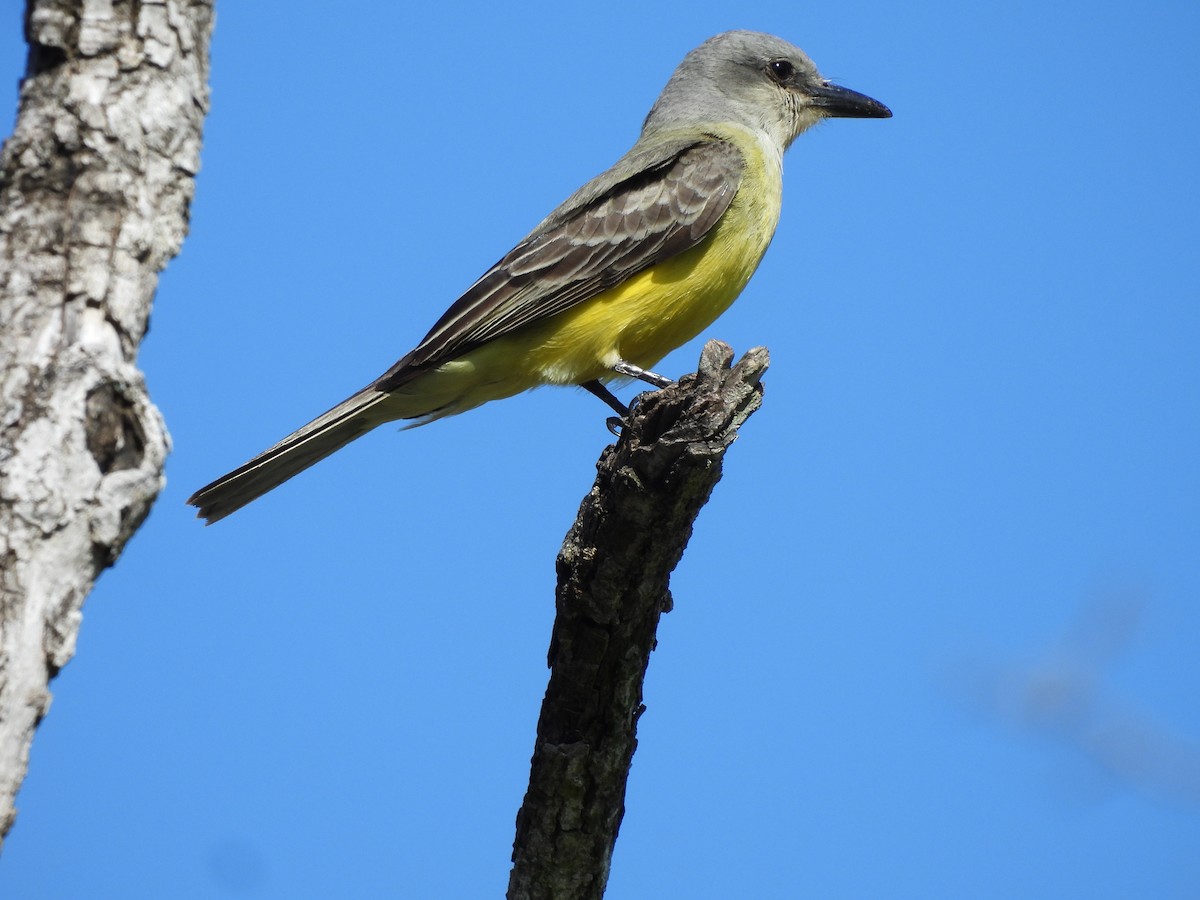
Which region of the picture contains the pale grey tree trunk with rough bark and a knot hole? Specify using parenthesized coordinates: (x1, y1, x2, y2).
(0, 0, 212, 839)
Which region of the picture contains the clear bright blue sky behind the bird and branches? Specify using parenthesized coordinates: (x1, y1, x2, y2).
(0, 0, 1200, 900)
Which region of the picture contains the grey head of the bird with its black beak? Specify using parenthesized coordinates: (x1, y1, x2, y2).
(643, 31, 892, 149)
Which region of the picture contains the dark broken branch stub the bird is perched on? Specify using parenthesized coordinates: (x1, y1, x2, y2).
(508, 341, 767, 900)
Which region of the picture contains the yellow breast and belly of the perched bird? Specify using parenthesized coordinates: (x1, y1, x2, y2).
(388, 125, 781, 419)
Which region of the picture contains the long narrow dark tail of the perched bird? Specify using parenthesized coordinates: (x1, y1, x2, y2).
(187, 388, 388, 524)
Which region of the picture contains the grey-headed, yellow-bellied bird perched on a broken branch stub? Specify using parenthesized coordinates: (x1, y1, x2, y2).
(187, 31, 892, 524)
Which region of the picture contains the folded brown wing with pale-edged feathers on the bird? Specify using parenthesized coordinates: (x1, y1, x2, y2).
(374, 138, 743, 390)
